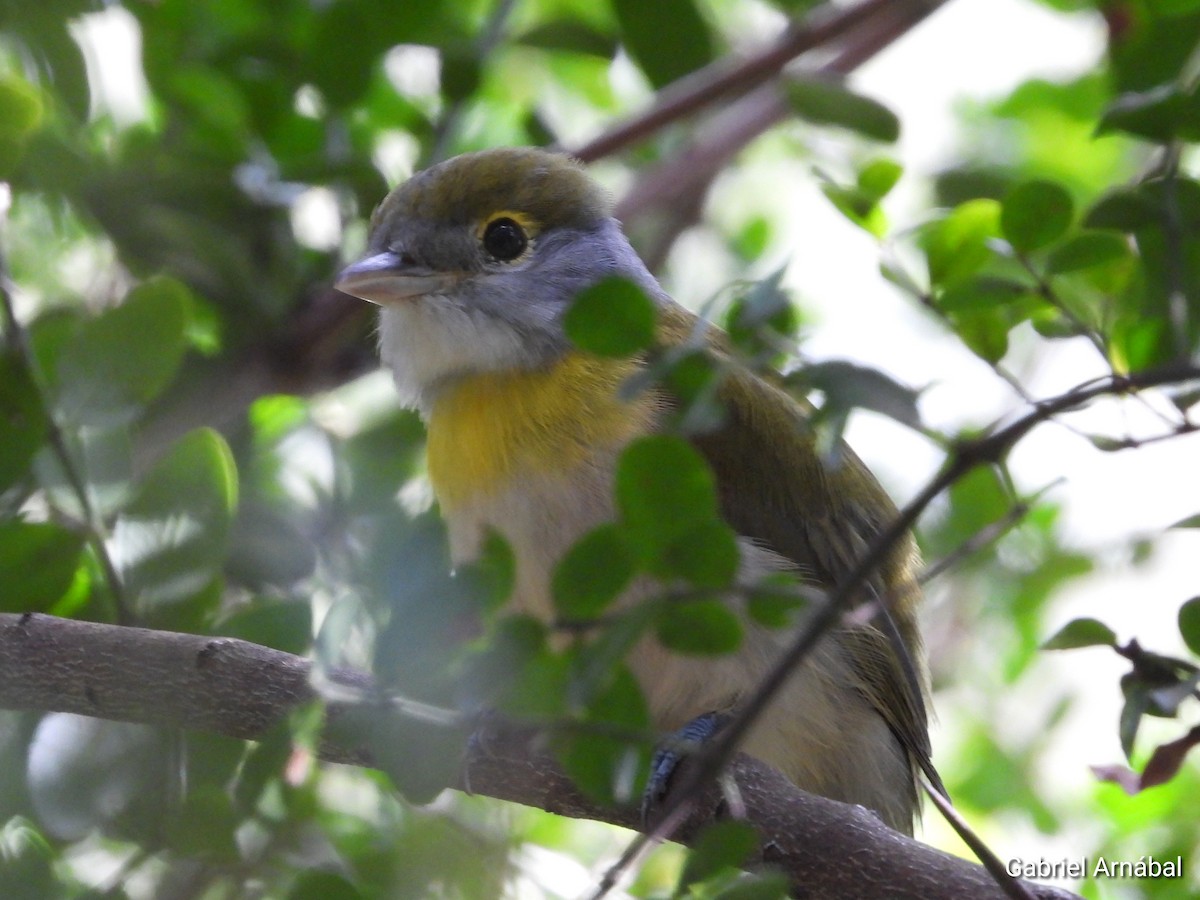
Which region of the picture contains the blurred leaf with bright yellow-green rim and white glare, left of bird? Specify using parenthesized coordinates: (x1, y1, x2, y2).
(112, 428, 238, 613)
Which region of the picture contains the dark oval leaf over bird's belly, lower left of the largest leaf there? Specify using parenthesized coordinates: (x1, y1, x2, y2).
(551, 522, 637, 619)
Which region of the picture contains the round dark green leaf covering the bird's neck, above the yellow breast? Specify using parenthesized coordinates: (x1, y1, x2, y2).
(563, 277, 656, 358)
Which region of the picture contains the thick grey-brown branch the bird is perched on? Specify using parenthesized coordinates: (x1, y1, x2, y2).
(0, 614, 1074, 900)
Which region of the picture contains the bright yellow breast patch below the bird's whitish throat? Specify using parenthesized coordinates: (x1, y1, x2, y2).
(428, 353, 654, 511)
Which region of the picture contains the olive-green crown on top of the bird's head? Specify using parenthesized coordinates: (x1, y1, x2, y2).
(371, 148, 612, 230)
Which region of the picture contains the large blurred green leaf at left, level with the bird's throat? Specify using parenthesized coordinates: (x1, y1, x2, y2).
(59, 276, 188, 425)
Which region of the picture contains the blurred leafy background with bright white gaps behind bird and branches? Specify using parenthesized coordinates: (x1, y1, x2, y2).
(0, 0, 1200, 898)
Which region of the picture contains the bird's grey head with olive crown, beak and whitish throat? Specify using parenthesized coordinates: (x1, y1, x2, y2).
(336, 148, 662, 409)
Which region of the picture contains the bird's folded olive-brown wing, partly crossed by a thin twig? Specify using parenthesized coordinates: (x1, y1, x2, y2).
(676, 338, 936, 779)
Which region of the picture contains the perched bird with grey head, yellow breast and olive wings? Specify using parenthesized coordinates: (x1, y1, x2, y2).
(336, 149, 929, 832)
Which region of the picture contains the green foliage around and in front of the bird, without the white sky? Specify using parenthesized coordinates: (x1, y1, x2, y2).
(0, 0, 1200, 898)
